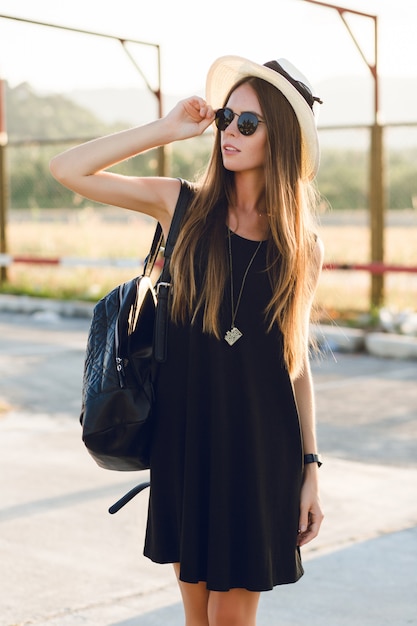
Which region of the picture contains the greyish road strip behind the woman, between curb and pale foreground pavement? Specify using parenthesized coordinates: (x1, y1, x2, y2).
(0, 312, 417, 467)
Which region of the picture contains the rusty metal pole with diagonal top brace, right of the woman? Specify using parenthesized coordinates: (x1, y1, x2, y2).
(304, 0, 386, 308)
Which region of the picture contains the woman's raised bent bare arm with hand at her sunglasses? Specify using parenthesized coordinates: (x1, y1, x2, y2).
(50, 97, 214, 225)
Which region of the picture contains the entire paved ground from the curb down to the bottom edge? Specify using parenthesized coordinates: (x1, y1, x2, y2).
(0, 312, 417, 626)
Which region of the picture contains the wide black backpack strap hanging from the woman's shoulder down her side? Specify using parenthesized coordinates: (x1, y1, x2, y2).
(154, 179, 193, 363)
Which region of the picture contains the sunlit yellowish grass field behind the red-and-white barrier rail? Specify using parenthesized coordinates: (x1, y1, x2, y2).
(3, 208, 417, 318)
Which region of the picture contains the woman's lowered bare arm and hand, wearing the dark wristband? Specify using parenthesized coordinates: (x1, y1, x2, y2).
(294, 236, 323, 546)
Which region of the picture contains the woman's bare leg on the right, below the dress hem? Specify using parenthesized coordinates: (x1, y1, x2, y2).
(208, 589, 260, 626)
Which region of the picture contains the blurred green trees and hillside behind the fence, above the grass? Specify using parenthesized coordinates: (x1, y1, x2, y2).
(6, 83, 417, 210)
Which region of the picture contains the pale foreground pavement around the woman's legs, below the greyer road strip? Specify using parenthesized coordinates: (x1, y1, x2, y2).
(0, 413, 417, 626)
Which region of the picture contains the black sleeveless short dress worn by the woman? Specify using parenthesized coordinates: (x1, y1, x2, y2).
(144, 224, 303, 591)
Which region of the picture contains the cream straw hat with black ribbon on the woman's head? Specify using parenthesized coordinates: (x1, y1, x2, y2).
(206, 56, 321, 180)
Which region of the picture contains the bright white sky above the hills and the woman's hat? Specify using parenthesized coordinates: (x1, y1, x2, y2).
(0, 0, 417, 97)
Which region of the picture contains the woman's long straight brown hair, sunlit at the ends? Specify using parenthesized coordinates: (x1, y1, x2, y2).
(171, 78, 316, 377)
